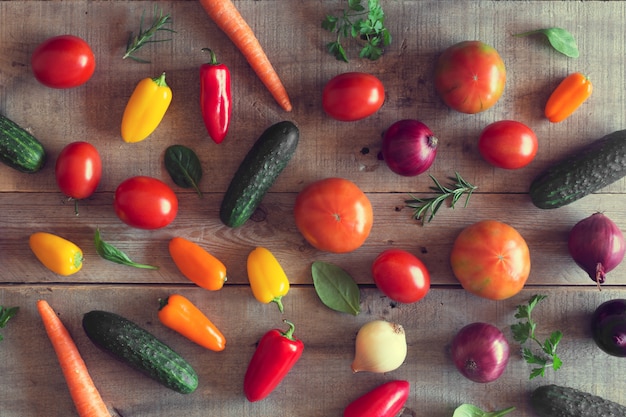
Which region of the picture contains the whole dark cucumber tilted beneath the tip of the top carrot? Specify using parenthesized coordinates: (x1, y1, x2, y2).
(220, 121, 300, 227)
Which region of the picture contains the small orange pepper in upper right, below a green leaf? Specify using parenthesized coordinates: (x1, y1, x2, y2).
(545, 72, 593, 123)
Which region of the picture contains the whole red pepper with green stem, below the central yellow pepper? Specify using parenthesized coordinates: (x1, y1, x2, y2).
(243, 320, 304, 402)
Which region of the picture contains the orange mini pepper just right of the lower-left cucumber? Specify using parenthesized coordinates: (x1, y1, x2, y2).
(158, 294, 226, 352)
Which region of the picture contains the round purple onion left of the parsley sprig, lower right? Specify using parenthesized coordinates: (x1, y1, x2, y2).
(452, 323, 509, 382)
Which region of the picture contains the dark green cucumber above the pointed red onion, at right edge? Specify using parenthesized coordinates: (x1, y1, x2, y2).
(530, 130, 626, 209)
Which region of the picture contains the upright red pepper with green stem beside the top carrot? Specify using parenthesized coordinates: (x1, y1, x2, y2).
(200, 48, 232, 143)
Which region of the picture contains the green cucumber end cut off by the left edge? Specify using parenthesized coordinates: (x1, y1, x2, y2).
(0, 114, 46, 174)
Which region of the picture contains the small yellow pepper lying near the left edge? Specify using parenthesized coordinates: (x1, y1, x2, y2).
(28, 232, 83, 276)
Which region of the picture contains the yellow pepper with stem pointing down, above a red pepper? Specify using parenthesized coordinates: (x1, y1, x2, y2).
(247, 247, 289, 313)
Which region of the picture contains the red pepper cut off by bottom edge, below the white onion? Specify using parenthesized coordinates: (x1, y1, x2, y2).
(343, 380, 410, 417)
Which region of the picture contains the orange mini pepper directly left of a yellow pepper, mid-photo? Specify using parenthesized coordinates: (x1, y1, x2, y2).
(169, 237, 227, 291)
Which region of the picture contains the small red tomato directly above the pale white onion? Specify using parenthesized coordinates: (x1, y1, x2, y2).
(372, 249, 430, 304)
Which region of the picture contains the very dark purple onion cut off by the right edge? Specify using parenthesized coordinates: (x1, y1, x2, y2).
(591, 298, 626, 358)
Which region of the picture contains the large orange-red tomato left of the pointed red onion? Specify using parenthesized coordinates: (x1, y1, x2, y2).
(450, 220, 530, 300)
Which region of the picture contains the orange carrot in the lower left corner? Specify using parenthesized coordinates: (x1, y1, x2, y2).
(37, 300, 111, 417)
